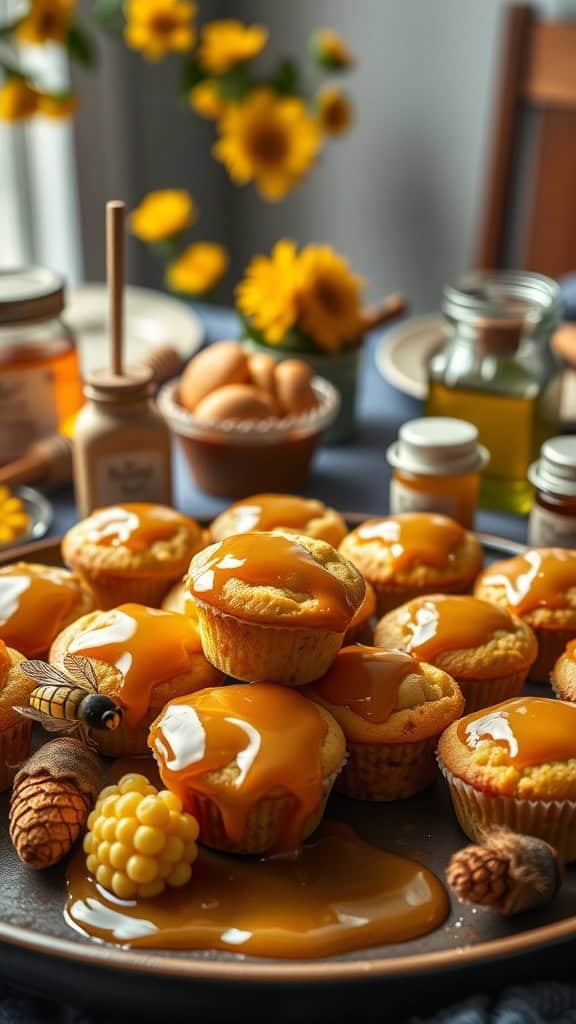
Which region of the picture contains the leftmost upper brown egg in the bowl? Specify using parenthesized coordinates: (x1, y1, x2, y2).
(179, 341, 249, 413)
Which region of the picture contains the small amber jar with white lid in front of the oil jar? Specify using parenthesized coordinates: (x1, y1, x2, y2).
(386, 416, 490, 528)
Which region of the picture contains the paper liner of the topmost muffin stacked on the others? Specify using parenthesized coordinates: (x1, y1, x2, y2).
(196, 601, 343, 686)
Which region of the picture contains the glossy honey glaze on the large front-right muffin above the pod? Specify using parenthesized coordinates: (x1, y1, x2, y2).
(457, 697, 576, 768)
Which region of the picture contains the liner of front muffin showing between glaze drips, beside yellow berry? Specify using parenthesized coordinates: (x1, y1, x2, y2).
(183, 772, 337, 853)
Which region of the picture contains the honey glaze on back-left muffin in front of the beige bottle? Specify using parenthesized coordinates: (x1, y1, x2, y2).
(87, 502, 191, 551)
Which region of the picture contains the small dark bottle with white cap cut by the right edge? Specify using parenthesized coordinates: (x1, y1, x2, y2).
(528, 435, 576, 548)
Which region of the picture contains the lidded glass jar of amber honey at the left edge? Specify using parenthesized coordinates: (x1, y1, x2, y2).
(0, 267, 82, 465)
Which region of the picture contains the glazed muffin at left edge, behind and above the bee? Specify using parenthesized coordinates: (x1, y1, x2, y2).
(0, 562, 94, 657)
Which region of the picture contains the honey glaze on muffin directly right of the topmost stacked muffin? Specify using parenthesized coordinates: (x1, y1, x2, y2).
(399, 594, 513, 662)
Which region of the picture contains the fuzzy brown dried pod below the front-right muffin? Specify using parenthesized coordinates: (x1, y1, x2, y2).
(446, 828, 563, 915)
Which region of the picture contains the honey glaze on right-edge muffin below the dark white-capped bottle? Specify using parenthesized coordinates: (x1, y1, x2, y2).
(482, 548, 576, 615)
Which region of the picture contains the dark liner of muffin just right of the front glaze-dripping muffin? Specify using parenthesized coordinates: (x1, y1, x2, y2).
(335, 736, 439, 801)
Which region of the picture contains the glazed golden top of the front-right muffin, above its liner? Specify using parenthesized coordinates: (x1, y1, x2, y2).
(438, 697, 576, 800)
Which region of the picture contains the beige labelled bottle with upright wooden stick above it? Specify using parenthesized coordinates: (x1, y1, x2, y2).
(74, 368, 172, 516)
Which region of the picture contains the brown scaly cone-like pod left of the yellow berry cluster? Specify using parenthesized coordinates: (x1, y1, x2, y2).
(9, 737, 101, 868)
